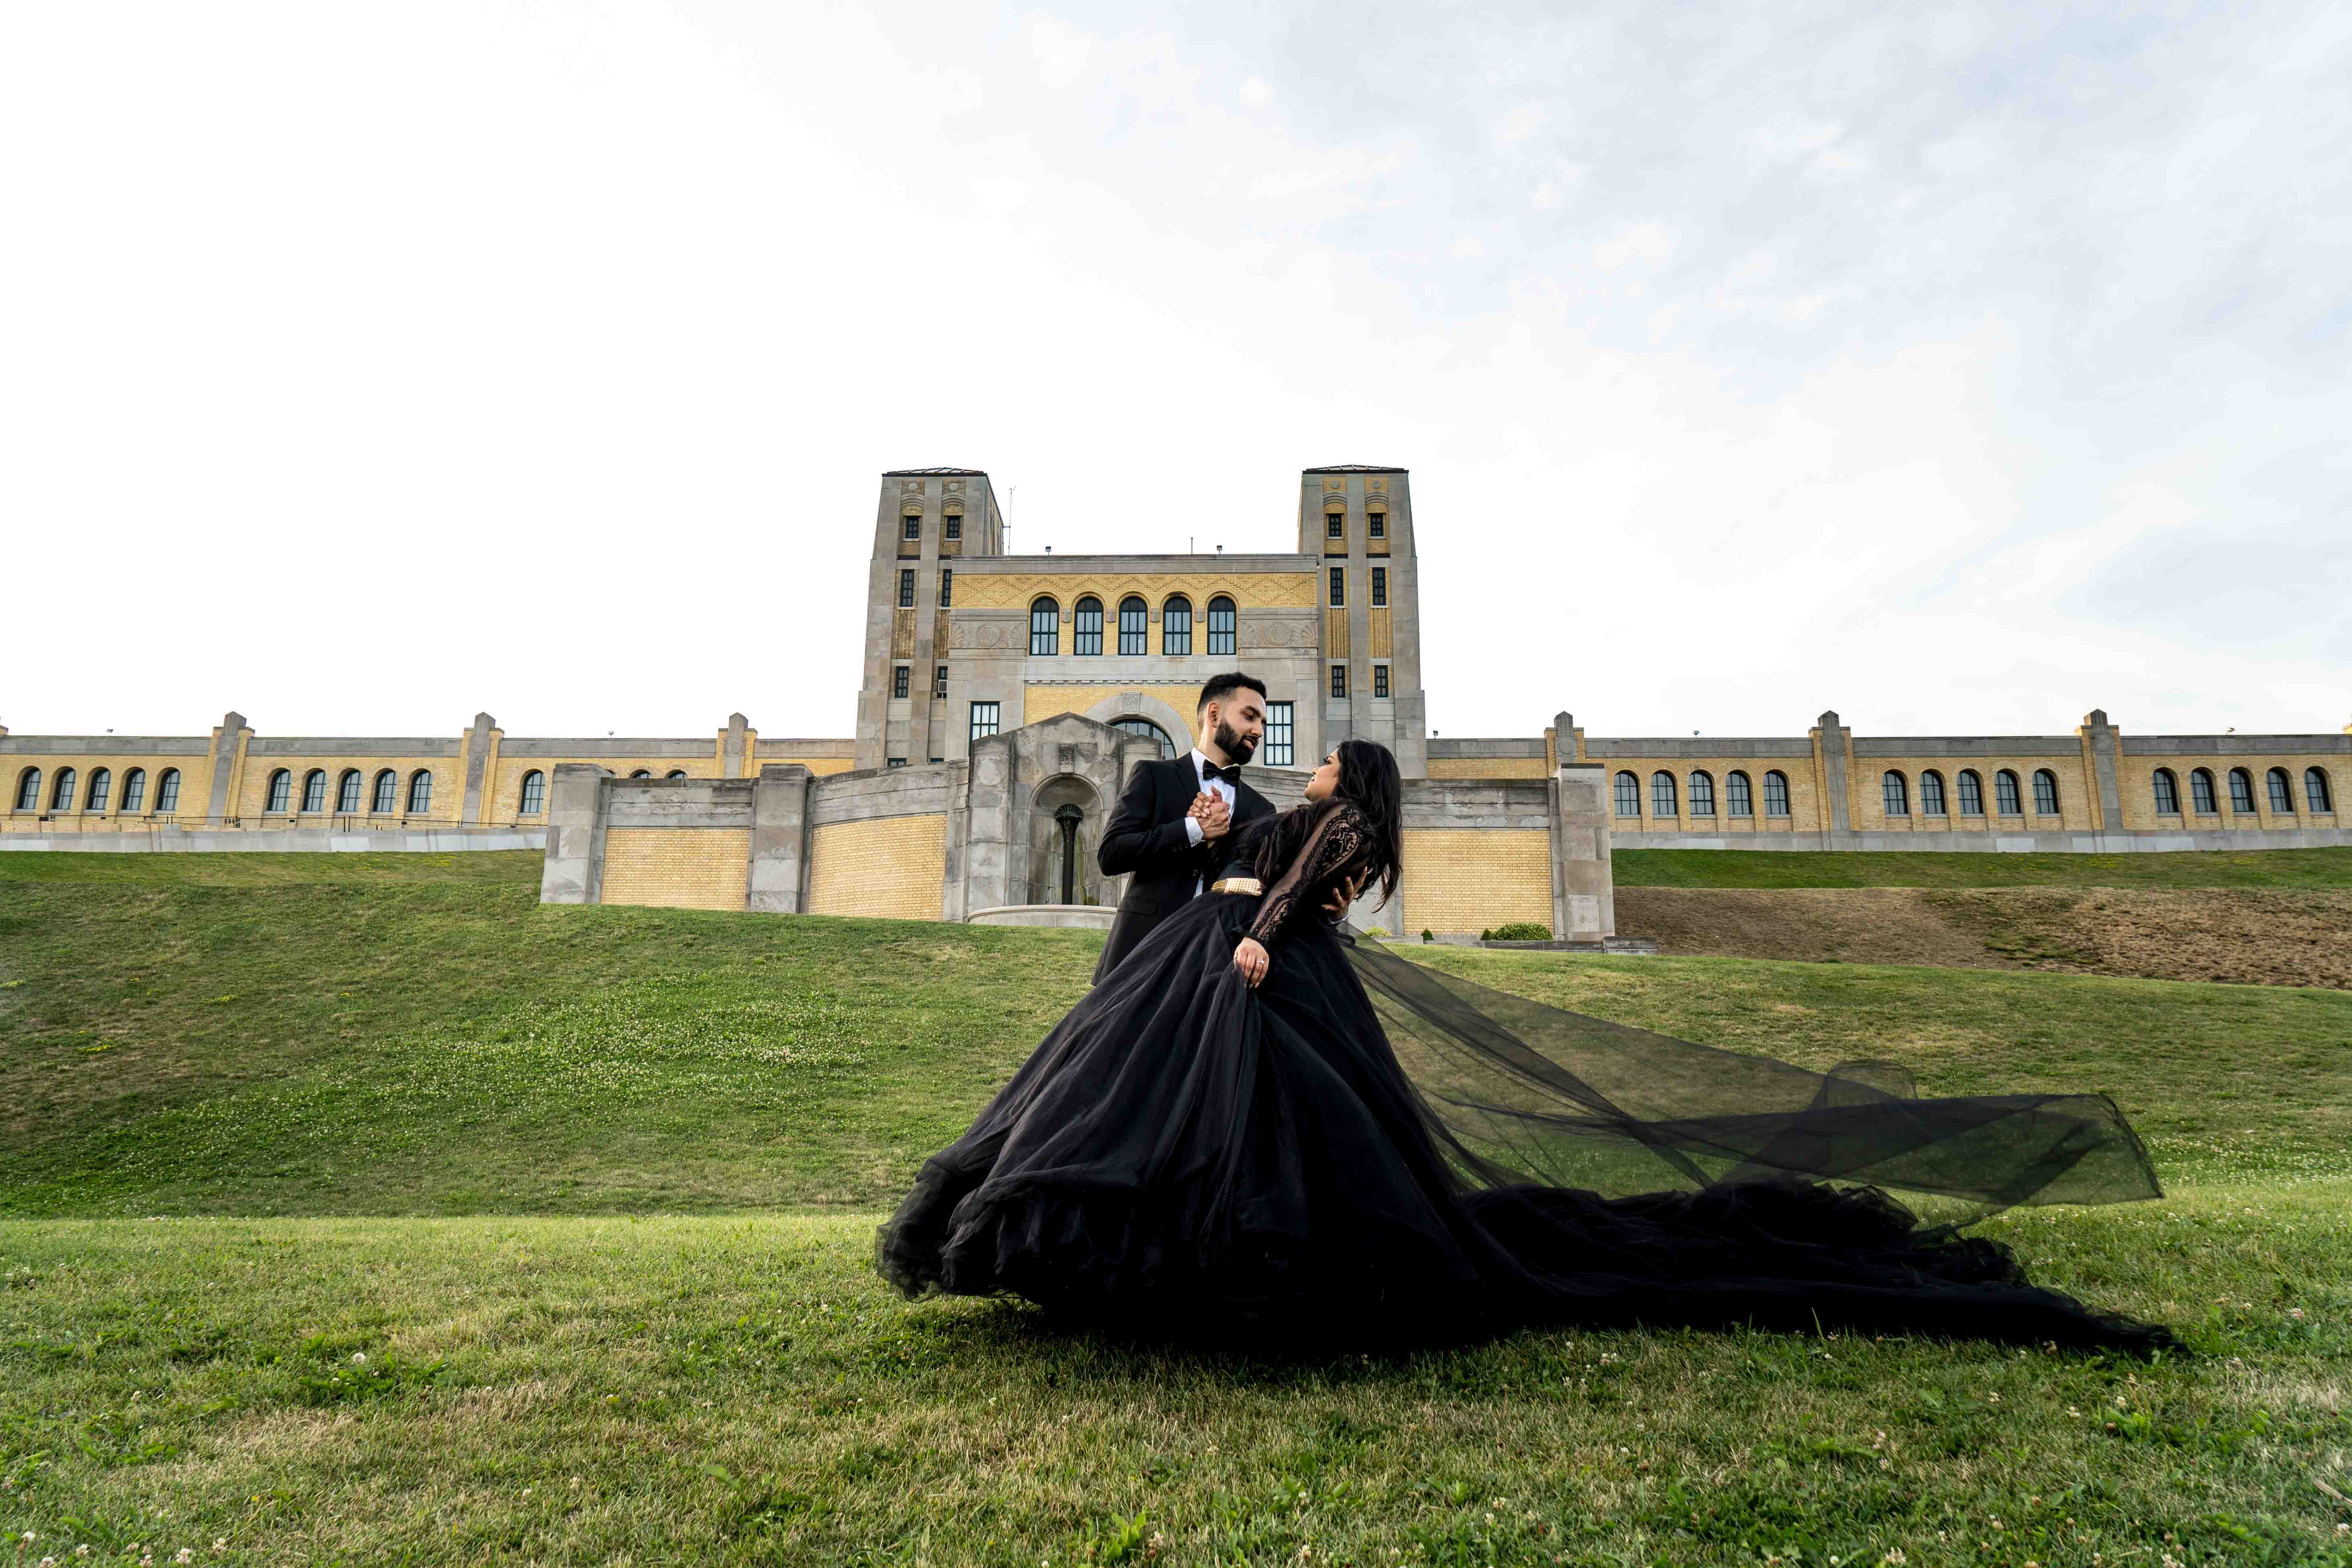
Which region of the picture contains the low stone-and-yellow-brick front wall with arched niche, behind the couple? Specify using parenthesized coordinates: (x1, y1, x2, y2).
(541, 715, 1616, 940)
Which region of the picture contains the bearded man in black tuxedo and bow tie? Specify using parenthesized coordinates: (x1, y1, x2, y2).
(1094, 670, 1275, 980)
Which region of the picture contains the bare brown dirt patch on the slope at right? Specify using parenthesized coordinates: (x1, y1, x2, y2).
(1616, 886, 2352, 990)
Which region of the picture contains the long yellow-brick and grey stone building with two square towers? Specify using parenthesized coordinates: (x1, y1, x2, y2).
(0, 465, 2352, 940)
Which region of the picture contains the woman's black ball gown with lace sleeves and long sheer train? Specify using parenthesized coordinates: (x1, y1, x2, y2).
(877, 801, 2175, 1349)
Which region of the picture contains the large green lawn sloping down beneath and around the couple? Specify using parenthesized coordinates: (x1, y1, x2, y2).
(0, 853, 2352, 1568)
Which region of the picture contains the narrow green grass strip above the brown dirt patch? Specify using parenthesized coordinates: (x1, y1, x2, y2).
(1611, 849, 2352, 888)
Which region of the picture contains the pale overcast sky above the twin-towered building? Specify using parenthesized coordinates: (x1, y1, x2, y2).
(0, 0, 2352, 736)
